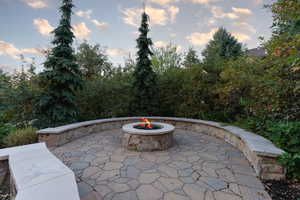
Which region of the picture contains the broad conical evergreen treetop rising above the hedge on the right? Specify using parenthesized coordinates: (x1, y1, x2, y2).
(202, 27, 243, 68)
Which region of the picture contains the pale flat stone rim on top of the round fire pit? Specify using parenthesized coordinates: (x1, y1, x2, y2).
(122, 122, 175, 135)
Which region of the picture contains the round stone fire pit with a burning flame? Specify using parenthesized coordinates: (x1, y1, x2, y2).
(122, 118, 175, 151)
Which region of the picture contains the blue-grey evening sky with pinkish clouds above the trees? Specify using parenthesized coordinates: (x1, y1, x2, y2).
(0, 0, 272, 72)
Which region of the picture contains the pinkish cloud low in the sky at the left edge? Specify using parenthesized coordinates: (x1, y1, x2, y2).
(0, 40, 44, 60)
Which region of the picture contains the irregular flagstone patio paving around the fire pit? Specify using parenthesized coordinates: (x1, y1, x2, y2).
(53, 130, 271, 200)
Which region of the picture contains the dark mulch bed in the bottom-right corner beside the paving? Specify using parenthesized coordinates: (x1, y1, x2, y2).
(263, 180, 300, 200)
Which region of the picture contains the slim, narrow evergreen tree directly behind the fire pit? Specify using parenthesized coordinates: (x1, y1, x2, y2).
(131, 12, 158, 115)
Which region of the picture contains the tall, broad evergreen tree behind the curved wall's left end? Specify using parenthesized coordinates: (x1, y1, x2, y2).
(38, 0, 82, 127)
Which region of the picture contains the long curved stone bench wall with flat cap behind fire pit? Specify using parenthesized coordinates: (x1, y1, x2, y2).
(37, 117, 285, 179)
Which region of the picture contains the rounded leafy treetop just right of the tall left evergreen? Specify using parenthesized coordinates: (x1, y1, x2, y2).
(76, 41, 112, 79)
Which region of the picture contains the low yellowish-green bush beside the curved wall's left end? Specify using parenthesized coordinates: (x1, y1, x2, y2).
(4, 127, 38, 147)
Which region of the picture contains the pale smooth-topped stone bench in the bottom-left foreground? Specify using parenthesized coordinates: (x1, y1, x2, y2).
(0, 143, 79, 200)
